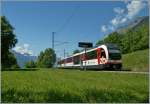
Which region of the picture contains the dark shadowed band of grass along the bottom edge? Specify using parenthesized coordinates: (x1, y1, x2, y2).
(1, 89, 148, 103)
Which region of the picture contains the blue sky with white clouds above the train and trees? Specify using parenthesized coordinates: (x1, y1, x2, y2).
(1, 0, 149, 57)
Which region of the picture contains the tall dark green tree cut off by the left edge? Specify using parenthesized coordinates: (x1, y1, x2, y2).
(1, 16, 17, 68)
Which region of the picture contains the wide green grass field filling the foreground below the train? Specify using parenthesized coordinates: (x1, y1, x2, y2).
(1, 69, 149, 103)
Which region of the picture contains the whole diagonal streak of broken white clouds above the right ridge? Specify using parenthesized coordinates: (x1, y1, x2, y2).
(101, 0, 146, 32)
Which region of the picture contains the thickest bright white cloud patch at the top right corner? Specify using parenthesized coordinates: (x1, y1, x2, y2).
(127, 0, 146, 19)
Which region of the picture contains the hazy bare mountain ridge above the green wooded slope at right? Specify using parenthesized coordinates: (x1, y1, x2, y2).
(117, 16, 149, 34)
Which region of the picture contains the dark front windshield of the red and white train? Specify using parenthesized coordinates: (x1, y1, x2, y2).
(109, 49, 121, 60)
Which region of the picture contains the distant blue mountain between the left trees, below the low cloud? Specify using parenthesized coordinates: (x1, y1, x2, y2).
(12, 50, 37, 68)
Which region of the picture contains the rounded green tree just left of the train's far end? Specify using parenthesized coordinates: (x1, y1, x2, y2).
(37, 48, 56, 68)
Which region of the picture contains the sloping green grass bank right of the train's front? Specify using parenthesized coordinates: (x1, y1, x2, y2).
(122, 49, 149, 71)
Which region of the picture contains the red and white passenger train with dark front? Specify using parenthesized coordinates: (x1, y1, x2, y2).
(57, 43, 122, 70)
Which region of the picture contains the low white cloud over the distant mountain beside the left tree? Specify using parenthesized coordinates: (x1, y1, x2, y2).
(13, 44, 33, 55)
